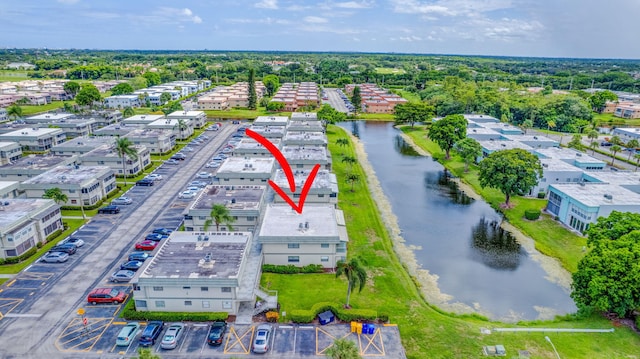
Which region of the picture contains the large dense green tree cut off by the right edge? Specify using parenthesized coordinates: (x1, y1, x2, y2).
(571, 211, 640, 317)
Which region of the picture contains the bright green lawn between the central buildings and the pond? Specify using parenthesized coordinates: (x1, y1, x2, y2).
(261, 126, 640, 359)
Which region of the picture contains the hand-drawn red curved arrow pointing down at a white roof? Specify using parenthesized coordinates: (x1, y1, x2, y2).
(245, 129, 320, 213)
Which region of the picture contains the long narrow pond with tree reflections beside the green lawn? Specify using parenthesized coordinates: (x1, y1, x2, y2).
(341, 121, 576, 321)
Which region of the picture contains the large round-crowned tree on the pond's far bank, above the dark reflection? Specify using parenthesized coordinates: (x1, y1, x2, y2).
(478, 148, 542, 207)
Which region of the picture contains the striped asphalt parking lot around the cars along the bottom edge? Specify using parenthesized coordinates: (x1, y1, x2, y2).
(56, 317, 405, 358)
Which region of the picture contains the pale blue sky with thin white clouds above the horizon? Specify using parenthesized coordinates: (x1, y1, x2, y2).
(0, 0, 640, 59)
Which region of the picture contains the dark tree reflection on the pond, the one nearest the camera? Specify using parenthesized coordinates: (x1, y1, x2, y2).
(471, 217, 526, 270)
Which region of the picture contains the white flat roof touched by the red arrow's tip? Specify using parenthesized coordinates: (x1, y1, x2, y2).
(258, 203, 340, 241)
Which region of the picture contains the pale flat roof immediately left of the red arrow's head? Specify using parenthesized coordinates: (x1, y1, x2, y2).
(190, 185, 267, 211)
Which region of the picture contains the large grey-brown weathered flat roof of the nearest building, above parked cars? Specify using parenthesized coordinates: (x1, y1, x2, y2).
(139, 231, 251, 279)
